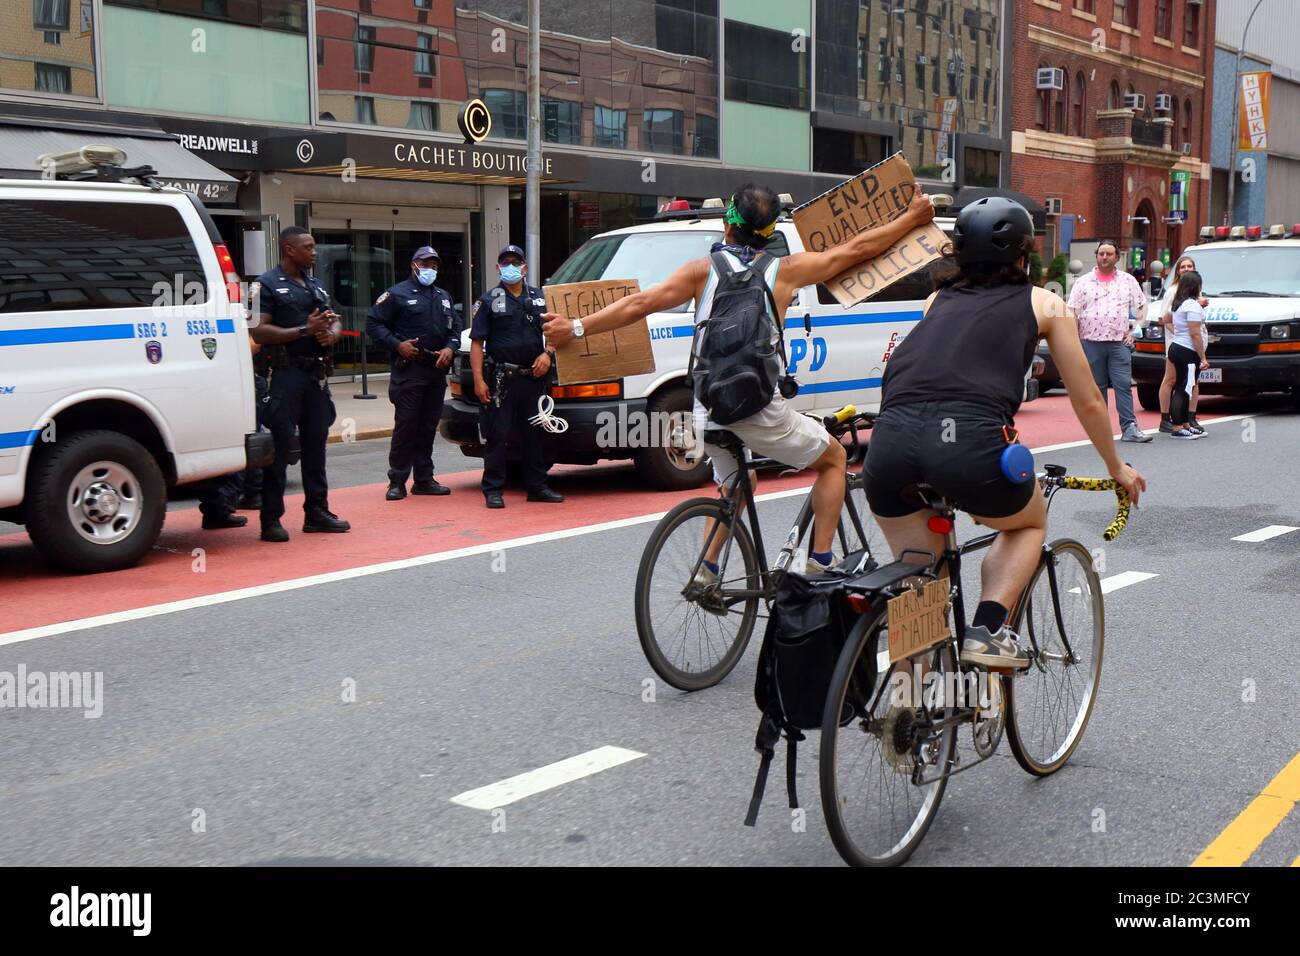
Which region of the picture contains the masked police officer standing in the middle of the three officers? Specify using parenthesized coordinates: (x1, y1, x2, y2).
(365, 246, 463, 501)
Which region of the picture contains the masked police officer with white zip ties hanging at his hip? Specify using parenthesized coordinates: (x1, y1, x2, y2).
(469, 246, 564, 507)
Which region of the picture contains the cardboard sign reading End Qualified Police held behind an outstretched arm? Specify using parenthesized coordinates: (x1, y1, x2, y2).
(793, 152, 948, 306)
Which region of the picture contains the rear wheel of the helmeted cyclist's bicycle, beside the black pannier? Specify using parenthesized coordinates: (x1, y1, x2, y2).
(818, 606, 957, 866)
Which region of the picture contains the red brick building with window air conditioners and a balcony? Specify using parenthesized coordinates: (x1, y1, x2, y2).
(1011, 0, 1217, 271)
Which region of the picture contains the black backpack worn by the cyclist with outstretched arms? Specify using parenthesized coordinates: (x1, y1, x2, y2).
(686, 252, 790, 425)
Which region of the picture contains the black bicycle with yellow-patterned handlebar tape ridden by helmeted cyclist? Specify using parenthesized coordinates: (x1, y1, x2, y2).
(820, 464, 1128, 866)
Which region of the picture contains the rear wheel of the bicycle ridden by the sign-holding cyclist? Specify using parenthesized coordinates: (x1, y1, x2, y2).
(636, 498, 762, 691)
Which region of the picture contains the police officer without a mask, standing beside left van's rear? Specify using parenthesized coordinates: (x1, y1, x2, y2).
(250, 226, 352, 542)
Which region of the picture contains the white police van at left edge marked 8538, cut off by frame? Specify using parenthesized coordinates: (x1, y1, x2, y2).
(0, 147, 272, 571)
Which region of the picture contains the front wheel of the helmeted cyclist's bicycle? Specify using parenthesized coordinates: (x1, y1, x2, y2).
(1002, 538, 1105, 777)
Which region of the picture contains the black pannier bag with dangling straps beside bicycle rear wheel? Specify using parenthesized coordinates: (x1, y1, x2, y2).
(745, 564, 876, 826)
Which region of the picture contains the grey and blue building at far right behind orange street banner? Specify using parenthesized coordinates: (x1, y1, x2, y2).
(1208, 0, 1300, 229)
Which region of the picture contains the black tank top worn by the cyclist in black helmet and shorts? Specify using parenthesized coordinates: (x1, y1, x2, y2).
(880, 285, 1039, 419)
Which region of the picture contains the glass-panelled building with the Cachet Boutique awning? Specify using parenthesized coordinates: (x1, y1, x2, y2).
(0, 0, 1011, 369)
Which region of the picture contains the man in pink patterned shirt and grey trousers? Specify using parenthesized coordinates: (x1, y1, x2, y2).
(1070, 241, 1152, 442)
